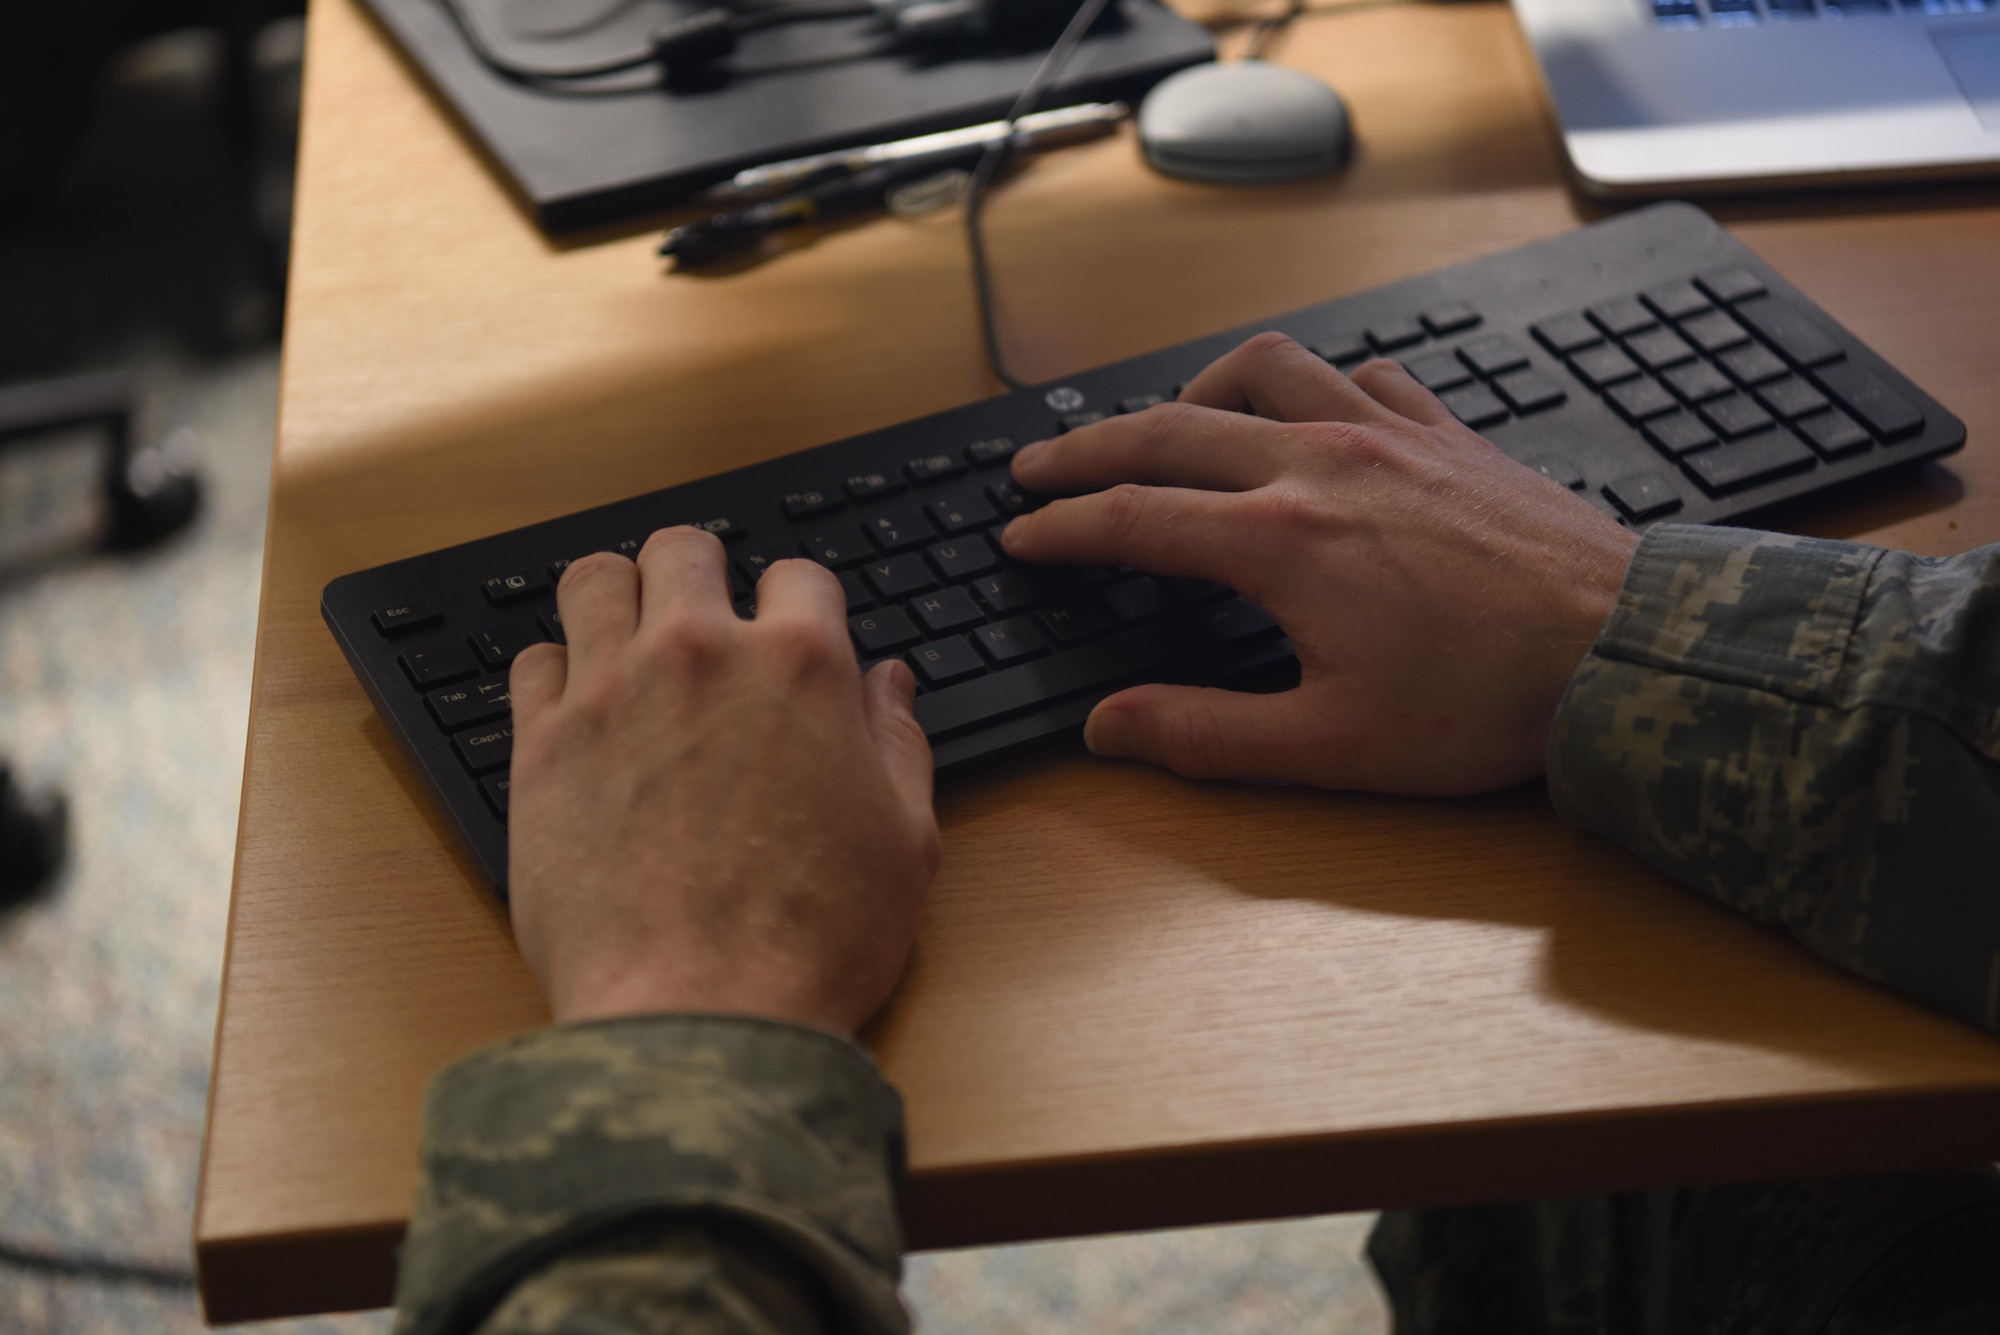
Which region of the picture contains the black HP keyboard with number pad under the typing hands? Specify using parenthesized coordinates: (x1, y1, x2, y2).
(320, 204, 1966, 893)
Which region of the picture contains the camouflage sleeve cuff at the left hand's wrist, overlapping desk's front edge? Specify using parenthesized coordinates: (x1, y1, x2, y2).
(396, 1015, 908, 1335)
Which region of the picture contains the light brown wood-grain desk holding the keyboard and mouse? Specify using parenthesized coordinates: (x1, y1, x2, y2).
(196, 0, 2000, 1321)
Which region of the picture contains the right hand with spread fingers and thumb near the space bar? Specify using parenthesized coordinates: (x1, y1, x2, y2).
(1004, 334, 1638, 793)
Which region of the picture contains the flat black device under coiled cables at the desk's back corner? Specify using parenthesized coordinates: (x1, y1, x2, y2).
(352, 0, 1216, 232)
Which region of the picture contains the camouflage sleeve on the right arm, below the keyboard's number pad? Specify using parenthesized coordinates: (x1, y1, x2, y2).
(1548, 526, 2000, 1033)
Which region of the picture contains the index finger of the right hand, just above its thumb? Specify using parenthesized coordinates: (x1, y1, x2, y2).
(1000, 484, 1248, 584)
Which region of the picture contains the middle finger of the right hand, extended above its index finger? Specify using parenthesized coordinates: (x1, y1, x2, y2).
(1014, 404, 1286, 494)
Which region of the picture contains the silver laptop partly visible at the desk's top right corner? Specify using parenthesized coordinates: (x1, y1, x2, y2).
(1514, 0, 2000, 196)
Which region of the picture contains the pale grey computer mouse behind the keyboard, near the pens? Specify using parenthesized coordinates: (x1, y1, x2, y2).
(1138, 60, 1354, 184)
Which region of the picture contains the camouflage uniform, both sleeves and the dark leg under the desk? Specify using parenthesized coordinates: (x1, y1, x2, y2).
(398, 526, 2000, 1335)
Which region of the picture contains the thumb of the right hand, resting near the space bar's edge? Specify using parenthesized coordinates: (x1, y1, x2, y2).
(1084, 685, 1310, 779)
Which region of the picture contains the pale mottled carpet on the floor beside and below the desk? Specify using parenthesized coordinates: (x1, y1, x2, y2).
(0, 20, 1388, 1335)
